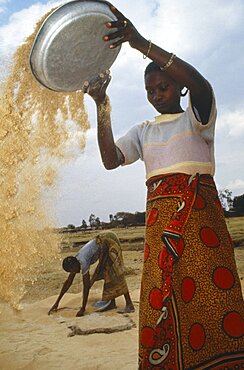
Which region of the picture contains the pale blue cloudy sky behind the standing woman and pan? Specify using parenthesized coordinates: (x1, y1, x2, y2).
(0, 0, 244, 226)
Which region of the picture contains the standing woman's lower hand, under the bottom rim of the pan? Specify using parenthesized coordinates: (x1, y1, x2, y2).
(82, 71, 111, 104)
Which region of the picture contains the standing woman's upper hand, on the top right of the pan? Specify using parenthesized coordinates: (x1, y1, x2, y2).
(103, 6, 146, 49)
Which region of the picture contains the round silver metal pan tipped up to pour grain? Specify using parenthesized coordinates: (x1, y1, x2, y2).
(30, 0, 120, 91)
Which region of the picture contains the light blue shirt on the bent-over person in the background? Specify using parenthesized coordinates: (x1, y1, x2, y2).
(75, 239, 99, 275)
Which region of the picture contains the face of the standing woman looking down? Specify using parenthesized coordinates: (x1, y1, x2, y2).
(145, 71, 183, 114)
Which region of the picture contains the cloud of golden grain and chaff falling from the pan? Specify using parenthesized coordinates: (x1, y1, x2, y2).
(0, 10, 89, 307)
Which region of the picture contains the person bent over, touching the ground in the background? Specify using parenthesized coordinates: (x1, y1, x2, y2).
(49, 232, 134, 316)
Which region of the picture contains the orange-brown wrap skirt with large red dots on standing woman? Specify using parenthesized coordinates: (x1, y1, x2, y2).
(139, 173, 244, 370)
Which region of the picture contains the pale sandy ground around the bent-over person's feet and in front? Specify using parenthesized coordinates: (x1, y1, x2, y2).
(0, 291, 138, 370)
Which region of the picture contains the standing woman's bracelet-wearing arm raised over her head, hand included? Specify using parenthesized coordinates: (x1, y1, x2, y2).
(104, 6, 212, 123)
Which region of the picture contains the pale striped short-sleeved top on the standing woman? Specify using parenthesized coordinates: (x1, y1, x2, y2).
(116, 92, 217, 179)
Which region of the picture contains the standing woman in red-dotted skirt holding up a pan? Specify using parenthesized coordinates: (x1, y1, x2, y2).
(85, 6, 244, 369)
